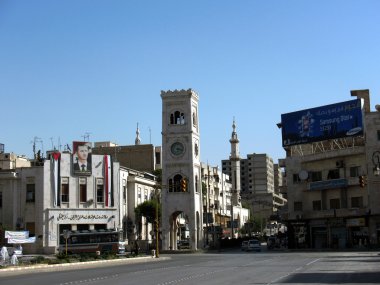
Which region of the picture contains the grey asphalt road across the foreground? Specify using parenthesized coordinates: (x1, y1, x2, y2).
(0, 251, 380, 285)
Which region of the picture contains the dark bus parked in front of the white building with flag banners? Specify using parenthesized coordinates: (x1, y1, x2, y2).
(58, 229, 125, 254)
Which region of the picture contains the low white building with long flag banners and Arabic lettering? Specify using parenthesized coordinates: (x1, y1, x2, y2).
(0, 144, 156, 253)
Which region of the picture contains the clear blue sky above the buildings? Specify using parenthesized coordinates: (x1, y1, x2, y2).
(0, 0, 380, 165)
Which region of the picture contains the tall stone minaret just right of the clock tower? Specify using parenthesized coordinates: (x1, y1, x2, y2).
(230, 118, 241, 206)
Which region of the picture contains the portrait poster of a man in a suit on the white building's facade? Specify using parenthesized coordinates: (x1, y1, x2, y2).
(72, 141, 92, 175)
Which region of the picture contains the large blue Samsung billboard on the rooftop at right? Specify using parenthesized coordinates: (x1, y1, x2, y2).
(281, 99, 363, 147)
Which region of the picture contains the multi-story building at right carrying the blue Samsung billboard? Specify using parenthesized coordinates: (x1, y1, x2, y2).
(280, 90, 380, 248)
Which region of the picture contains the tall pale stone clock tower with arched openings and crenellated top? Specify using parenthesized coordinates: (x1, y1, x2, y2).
(161, 89, 203, 250)
